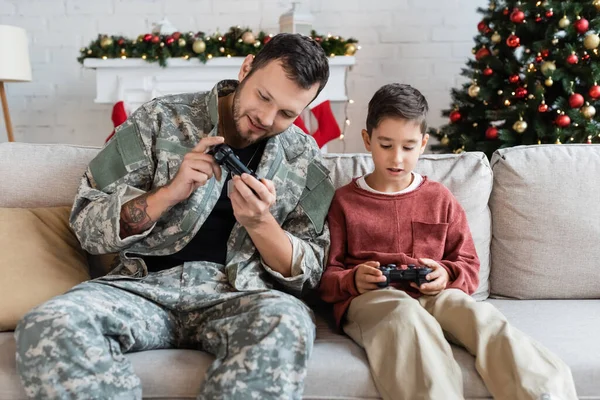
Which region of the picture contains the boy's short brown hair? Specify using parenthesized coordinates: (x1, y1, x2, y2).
(367, 83, 429, 136)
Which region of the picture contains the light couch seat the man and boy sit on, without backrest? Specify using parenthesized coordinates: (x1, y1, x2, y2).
(0, 300, 600, 400)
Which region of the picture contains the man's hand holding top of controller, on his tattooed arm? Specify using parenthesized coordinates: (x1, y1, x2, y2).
(164, 136, 224, 206)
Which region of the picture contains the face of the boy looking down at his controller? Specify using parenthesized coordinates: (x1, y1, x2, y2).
(362, 118, 429, 191)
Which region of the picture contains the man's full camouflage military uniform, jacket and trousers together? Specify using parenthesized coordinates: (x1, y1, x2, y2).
(15, 81, 334, 399)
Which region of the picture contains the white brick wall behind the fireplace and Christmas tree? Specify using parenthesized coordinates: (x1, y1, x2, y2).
(0, 0, 488, 152)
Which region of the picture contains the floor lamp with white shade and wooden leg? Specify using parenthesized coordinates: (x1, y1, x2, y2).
(0, 25, 31, 142)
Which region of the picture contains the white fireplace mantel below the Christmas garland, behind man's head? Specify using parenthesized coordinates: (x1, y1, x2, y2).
(84, 56, 356, 112)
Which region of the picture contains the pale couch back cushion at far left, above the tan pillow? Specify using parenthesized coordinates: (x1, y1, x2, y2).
(0, 143, 99, 207)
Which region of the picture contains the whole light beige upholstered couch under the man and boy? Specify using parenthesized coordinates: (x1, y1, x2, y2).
(0, 143, 600, 400)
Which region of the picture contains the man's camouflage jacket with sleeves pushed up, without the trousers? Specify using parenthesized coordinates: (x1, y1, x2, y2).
(70, 81, 334, 295)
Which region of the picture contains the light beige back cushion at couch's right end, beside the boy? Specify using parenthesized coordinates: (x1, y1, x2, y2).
(490, 144, 600, 299)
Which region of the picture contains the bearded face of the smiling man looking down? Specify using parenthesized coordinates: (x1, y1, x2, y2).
(232, 56, 319, 147)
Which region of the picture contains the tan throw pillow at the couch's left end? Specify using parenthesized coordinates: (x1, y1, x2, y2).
(0, 207, 90, 331)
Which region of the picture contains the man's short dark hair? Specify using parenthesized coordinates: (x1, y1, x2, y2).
(248, 33, 329, 97)
